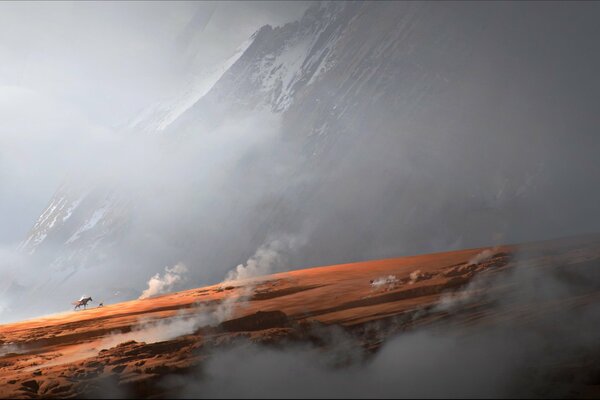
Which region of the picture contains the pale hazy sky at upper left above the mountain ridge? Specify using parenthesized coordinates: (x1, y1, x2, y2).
(0, 1, 308, 244)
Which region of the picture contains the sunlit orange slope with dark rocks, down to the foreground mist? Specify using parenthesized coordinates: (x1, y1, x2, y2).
(0, 236, 600, 398)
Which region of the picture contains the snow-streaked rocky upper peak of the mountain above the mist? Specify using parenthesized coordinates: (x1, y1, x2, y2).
(204, 2, 361, 112)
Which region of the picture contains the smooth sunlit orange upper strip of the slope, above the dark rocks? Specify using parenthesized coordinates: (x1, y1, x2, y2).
(0, 247, 496, 343)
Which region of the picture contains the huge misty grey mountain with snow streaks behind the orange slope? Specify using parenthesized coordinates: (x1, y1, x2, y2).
(12, 2, 600, 318)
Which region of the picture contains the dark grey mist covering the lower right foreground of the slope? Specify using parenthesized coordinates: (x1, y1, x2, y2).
(154, 244, 600, 398)
